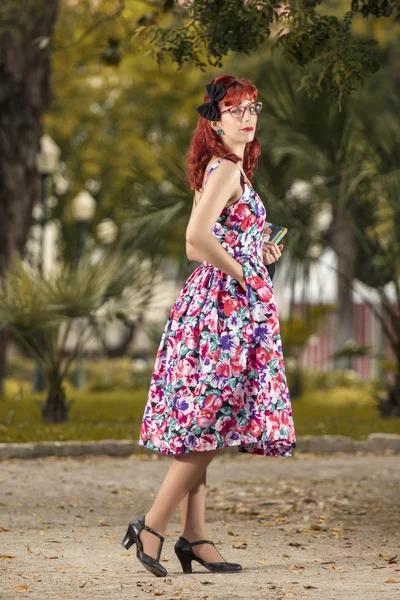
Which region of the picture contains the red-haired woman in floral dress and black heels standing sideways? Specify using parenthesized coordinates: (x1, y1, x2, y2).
(122, 75, 296, 576)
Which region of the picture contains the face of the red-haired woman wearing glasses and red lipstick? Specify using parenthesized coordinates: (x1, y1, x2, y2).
(212, 98, 258, 144)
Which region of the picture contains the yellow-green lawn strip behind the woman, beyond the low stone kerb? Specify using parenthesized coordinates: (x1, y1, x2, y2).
(0, 379, 400, 442)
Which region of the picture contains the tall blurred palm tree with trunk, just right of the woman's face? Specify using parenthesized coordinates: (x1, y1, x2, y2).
(253, 61, 384, 369)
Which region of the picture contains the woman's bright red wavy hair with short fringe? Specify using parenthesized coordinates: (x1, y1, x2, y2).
(186, 75, 261, 190)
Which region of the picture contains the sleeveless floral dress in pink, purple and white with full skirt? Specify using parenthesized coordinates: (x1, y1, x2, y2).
(139, 159, 296, 456)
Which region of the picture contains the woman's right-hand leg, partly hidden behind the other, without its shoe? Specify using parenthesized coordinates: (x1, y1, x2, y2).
(179, 469, 228, 562)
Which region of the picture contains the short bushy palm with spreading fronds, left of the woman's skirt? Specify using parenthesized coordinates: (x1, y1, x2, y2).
(0, 248, 159, 423)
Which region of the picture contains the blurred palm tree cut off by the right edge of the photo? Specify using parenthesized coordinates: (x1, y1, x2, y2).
(353, 101, 400, 417)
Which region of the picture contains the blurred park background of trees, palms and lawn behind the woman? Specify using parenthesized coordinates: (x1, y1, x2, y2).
(0, 0, 400, 442)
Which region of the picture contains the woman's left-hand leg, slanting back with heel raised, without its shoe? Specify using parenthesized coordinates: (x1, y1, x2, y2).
(140, 450, 219, 558)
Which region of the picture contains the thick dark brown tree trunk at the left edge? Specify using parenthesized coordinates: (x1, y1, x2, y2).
(0, 0, 58, 394)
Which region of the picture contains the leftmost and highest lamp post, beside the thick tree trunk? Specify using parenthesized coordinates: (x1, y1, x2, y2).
(32, 135, 61, 392)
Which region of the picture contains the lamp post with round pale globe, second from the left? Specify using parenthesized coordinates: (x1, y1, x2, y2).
(71, 190, 96, 388)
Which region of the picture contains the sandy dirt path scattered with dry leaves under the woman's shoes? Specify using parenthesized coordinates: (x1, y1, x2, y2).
(0, 452, 400, 600)
